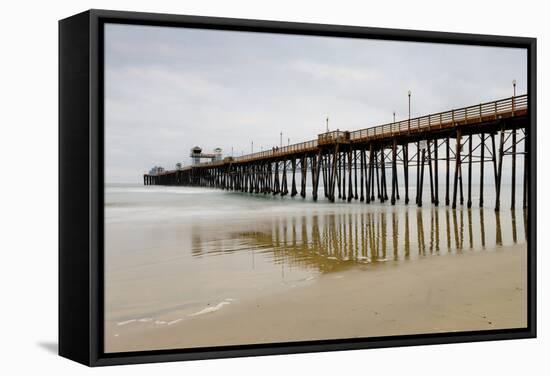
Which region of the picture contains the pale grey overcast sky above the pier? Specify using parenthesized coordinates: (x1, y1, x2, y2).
(105, 24, 527, 183)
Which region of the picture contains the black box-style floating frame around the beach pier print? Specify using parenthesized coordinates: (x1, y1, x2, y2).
(59, 9, 537, 366)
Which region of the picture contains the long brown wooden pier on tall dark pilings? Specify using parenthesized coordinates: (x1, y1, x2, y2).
(143, 95, 529, 211)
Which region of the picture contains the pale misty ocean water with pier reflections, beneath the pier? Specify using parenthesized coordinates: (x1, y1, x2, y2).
(105, 185, 527, 325)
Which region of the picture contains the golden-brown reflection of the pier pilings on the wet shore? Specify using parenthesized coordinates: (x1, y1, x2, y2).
(193, 208, 527, 272)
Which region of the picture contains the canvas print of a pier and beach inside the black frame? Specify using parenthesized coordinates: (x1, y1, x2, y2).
(103, 23, 529, 353)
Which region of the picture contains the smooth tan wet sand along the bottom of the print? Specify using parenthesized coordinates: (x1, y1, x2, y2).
(105, 244, 527, 352)
